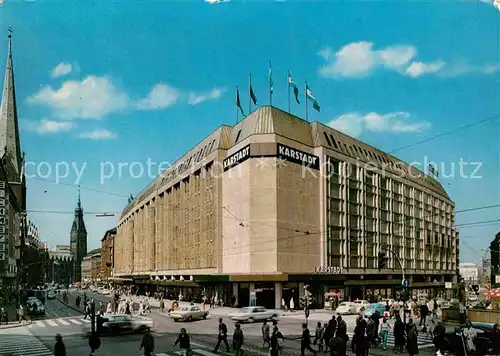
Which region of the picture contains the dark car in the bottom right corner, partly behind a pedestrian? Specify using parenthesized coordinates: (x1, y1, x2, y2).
(444, 322, 500, 355)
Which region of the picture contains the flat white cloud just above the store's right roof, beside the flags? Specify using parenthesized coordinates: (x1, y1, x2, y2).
(328, 112, 431, 137)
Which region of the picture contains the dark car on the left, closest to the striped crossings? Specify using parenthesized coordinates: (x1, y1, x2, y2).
(84, 314, 154, 334)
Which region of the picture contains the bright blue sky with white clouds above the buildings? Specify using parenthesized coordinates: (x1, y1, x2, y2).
(0, 0, 500, 262)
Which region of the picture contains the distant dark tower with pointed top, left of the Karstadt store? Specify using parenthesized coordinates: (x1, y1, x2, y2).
(70, 189, 87, 282)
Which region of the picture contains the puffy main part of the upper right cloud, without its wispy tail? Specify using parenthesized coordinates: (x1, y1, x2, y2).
(318, 41, 417, 78)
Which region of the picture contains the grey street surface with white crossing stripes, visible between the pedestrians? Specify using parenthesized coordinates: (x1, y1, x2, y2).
(0, 292, 438, 356)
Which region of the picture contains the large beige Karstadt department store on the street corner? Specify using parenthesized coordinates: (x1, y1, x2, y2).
(114, 107, 457, 307)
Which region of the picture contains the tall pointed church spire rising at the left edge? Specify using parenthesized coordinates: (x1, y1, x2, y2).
(0, 26, 22, 172)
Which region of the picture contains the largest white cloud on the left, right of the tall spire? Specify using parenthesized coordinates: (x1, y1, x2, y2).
(28, 76, 129, 119)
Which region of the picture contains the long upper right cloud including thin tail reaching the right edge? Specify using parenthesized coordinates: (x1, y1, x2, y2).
(318, 41, 500, 78)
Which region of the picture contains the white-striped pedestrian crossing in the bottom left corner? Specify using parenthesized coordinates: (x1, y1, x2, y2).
(0, 327, 54, 356)
